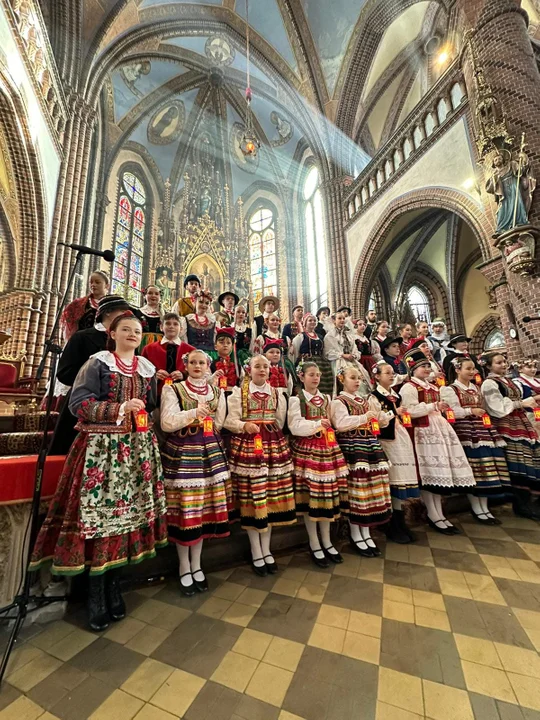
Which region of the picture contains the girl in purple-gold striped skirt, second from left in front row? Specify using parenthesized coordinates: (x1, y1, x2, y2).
(161, 350, 231, 597)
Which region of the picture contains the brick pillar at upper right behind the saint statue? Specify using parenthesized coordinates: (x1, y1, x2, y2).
(456, 0, 540, 358)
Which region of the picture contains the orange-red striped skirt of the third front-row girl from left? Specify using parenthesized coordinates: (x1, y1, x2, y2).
(229, 421, 296, 532)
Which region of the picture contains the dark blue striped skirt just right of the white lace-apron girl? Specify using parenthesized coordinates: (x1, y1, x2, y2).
(454, 415, 510, 497)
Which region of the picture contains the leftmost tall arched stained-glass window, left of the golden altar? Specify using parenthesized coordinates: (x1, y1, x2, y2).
(111, 172, 146, 307)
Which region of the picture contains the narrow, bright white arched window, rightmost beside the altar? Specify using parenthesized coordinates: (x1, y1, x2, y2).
(303, 167, 328, 313)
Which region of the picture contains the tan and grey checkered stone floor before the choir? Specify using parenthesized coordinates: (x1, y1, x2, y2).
(0, 509, 540, 720)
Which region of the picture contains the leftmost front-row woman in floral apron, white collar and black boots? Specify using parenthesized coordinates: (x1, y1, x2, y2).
(30, 312, 167, 631)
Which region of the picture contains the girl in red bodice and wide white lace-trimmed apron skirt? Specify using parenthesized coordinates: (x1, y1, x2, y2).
(400, 349, 476, 535)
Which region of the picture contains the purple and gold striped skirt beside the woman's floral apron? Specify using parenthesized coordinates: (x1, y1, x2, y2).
(161, 427, 232, 545)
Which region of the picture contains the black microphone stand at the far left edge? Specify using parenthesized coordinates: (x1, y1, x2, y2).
(0, 252, 83, 685)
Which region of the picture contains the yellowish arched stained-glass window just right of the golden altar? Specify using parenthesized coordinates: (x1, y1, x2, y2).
(249, 207, 278, 303)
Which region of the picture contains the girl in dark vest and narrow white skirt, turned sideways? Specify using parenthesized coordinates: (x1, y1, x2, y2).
(373, 361, 420, 544)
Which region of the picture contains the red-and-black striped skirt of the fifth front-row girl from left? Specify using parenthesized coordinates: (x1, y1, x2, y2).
(337, 429, 392, 527)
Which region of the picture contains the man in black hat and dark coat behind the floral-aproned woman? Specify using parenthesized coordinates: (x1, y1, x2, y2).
(49, 295, 130, 455)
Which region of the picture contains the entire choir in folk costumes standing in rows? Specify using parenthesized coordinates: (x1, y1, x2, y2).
(31, 272, 540, 631)
